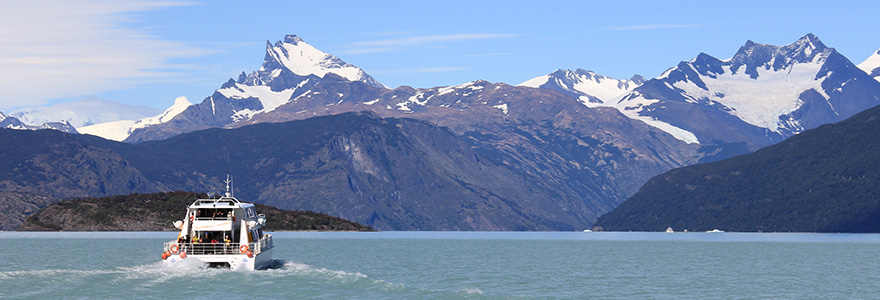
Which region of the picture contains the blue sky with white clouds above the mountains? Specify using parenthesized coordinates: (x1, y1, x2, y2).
(0, 0, 880, 111)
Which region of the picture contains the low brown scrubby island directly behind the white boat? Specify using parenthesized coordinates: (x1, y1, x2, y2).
(18, 192, 374, 231)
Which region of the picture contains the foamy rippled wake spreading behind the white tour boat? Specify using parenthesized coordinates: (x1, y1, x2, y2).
(0, 259, 492, 299)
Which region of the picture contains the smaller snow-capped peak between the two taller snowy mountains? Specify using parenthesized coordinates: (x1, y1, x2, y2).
(519, 69, 645, 106)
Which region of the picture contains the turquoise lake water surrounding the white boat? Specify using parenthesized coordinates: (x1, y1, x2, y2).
(0, 232, 880, 299)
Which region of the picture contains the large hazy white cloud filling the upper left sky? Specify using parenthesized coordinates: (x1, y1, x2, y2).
(0, 0, 209, 109)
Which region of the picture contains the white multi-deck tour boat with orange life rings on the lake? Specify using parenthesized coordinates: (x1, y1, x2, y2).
(162, 176, 274, 270)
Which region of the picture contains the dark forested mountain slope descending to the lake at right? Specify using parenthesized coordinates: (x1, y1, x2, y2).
(595, 102, 880, 233)
